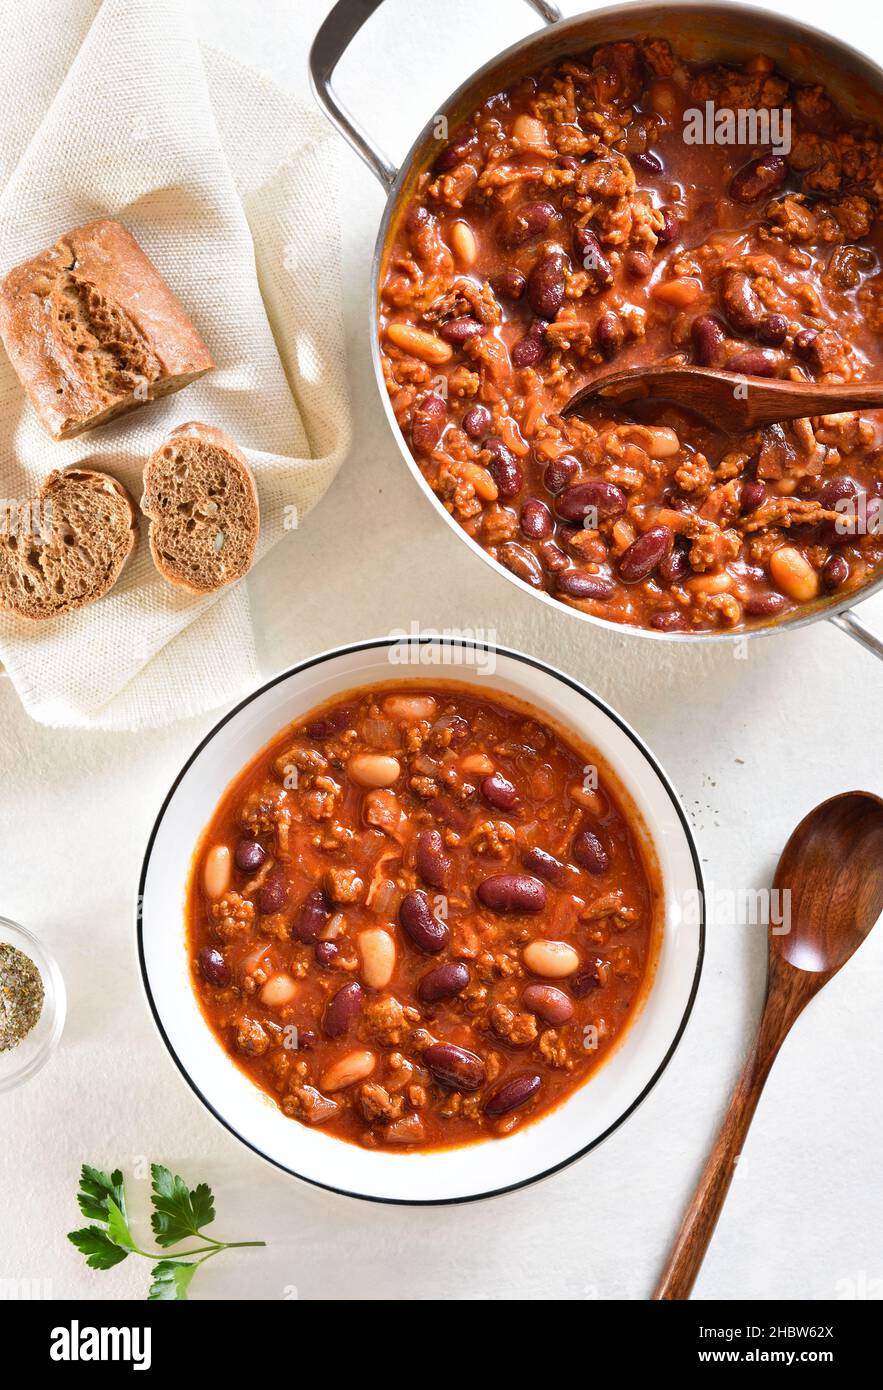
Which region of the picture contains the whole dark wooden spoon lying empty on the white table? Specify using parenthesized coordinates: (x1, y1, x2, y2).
(654, 791, 883, 1300)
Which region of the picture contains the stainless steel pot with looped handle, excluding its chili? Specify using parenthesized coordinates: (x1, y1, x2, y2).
(310, 0, 883, 657)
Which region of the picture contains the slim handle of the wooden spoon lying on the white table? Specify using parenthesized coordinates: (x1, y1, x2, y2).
(654, 1013, 787, 1300)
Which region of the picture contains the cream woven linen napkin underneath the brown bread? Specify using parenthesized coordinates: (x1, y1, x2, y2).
(0, 0, 350, 728)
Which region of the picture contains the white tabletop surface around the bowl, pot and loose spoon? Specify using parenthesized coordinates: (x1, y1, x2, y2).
(0, 0, 883, 1300)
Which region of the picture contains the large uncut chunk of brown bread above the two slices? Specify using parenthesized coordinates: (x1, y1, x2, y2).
(0, 218, 214, 439)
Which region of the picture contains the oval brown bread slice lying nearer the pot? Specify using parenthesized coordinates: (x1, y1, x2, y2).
(140, 421, 260, 594)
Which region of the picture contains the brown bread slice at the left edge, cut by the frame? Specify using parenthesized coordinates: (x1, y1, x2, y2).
(0, 467, 138, 619)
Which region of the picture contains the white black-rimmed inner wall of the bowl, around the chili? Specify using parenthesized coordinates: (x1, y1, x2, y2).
(136, 635, 705, 1204)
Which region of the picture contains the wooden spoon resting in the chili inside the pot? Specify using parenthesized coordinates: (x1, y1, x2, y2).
(562, 367, 883, 434)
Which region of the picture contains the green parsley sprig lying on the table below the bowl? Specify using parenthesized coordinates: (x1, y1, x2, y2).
(68, 1163, 266, 1300)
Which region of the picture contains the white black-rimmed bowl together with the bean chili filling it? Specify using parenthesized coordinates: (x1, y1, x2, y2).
(139, 639, 702, 1201)
